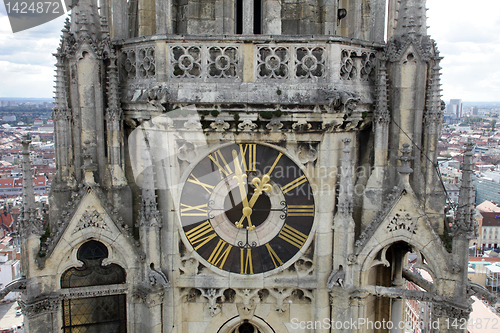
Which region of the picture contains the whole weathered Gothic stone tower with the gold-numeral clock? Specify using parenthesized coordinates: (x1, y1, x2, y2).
(9, 0, 494, 333)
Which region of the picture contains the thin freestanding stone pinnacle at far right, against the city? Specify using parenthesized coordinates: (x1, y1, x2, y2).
(452, 138, 477, 239)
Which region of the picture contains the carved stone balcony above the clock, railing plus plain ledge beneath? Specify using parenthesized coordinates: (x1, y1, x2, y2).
(120, 36, 381, 104)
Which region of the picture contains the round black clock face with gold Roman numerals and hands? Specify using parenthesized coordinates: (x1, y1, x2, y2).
(179, 144, 314, 274)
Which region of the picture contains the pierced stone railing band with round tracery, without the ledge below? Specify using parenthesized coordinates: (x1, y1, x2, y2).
(120, 39, 377, 85)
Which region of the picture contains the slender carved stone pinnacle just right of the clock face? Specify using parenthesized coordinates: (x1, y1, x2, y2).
(338, 139, 353, 215)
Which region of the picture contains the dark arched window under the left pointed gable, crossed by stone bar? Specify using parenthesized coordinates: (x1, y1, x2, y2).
(61, 240, 127, 333)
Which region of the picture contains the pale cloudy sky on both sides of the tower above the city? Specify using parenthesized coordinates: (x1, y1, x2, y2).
(0, 0, 500, 102)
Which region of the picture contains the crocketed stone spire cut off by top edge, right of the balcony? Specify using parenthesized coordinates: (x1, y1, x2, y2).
(394, 0, 427, 36)
